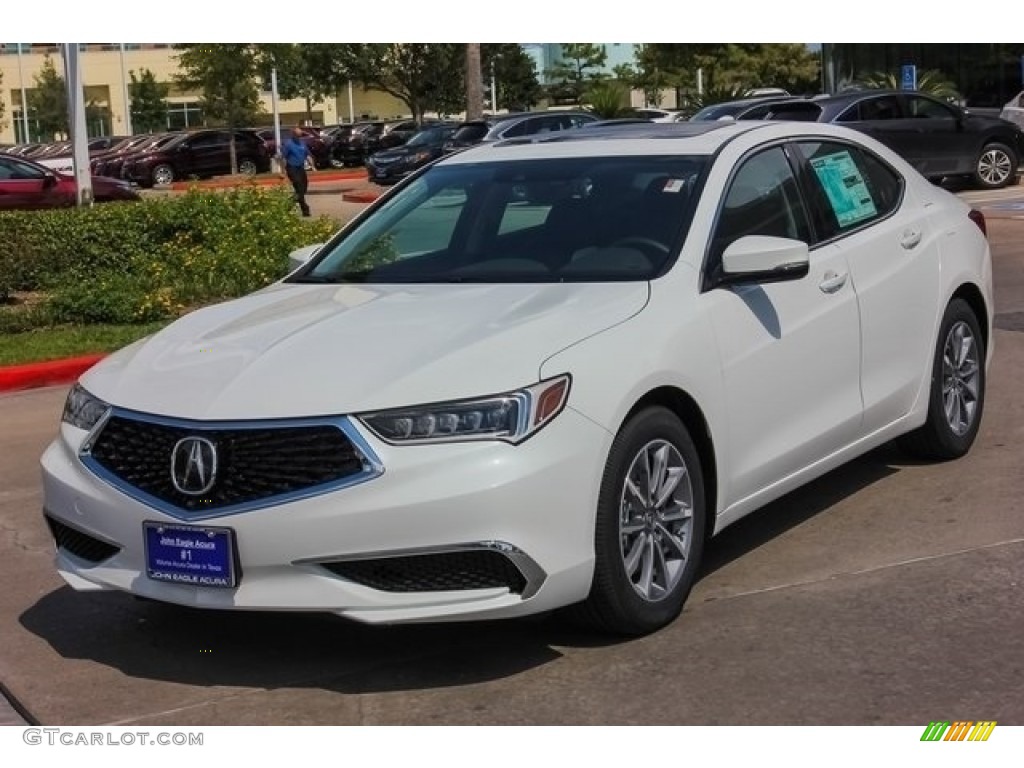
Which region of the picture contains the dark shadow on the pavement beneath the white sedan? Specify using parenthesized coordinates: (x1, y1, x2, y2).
(19, 447, 901, 693)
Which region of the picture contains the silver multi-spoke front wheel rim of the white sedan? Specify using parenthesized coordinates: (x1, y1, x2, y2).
(618, 439, 693, 602)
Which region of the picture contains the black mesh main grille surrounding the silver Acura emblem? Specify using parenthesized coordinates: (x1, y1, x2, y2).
(91, 416, 364, 513)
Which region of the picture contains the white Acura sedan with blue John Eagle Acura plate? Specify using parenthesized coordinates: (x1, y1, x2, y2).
(43, 122, 992, 634)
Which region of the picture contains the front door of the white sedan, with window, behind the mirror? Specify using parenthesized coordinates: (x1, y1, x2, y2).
(703, 145, 862, 501)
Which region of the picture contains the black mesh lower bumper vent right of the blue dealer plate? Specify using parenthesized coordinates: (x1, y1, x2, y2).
(321, 550, 526, 595)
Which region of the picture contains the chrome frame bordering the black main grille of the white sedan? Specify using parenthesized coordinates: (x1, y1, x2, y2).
(78, 407, 384, 522)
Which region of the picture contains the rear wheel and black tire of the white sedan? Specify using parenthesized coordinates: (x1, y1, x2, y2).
(899, 299, 985, 461)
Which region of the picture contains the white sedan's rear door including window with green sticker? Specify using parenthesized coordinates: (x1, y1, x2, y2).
(797, 140, 940, 434)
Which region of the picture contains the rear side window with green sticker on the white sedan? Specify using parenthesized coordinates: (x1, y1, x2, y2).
(798, 141, 903, 240)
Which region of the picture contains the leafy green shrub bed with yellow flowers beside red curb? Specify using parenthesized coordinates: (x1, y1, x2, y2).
(0, 186, 337, 326)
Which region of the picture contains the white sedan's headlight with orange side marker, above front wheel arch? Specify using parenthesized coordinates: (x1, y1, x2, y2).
(358, 374, 569, 444)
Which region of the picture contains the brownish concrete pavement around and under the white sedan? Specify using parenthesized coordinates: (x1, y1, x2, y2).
(0, 187, 1024, 725)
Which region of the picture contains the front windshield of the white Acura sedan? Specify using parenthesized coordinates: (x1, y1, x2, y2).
(291, 156, 707, 284)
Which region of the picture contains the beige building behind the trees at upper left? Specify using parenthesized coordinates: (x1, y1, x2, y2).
(0, 43, 409, 145)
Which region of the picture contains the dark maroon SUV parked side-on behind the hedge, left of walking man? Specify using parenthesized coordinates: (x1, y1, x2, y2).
(121, 129, 270, 186)
